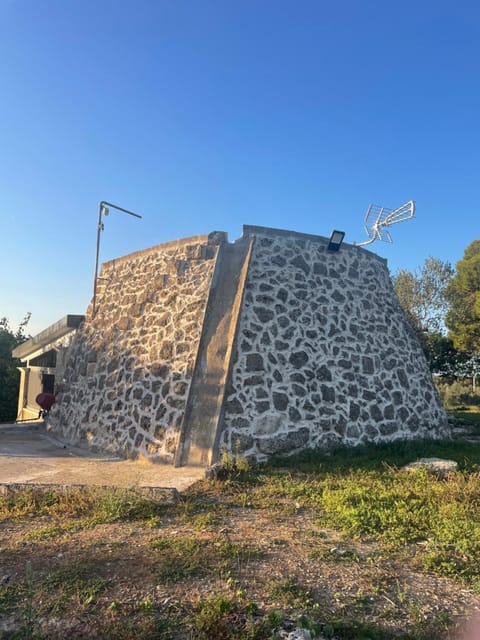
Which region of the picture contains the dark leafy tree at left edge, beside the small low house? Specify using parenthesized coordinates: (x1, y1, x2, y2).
(0, 313, 31, 423)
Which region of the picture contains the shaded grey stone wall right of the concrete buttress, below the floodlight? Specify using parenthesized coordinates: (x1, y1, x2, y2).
(222, 227, 447, 460)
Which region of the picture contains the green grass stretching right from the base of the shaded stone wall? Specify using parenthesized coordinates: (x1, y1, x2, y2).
(210, 441, 480, 589)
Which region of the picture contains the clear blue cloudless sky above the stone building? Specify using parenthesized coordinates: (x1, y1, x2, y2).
(0, 0, 480, 333)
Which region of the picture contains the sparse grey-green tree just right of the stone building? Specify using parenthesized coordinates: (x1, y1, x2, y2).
(392, 257, 454, 334)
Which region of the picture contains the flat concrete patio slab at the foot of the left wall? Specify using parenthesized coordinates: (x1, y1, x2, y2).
(0, 422, 205, 491)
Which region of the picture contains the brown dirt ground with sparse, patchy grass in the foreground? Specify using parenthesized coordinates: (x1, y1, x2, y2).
(0, 492, 480, 640)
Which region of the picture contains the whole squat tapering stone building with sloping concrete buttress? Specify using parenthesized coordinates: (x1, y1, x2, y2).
(49, 226, 448, 465)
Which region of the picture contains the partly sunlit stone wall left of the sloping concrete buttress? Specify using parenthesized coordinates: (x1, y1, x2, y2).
(49, 234, 223, 461)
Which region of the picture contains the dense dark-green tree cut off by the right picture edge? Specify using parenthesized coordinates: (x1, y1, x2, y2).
(445, 240, 480, 355)
